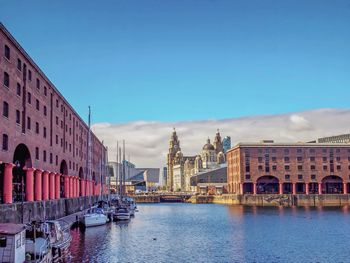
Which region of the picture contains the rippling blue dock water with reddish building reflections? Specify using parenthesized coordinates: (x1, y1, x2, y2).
(71, 204, 350, 262)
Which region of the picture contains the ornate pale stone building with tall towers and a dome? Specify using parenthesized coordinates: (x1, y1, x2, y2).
(167, 129, 226, 191)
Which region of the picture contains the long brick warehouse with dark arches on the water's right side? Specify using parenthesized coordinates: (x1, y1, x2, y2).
(227, 141, 350, 194)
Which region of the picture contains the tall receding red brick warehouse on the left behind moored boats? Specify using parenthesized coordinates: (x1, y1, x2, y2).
(0, 23, 107, 203)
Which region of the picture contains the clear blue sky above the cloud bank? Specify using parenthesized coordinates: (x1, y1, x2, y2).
(0, 0, 350, 123)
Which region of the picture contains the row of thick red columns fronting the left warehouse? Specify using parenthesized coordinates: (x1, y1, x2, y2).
(3, 163, 101, 204)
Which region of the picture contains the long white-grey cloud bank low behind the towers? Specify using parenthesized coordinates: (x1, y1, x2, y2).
(92, 109, 350, 167)
